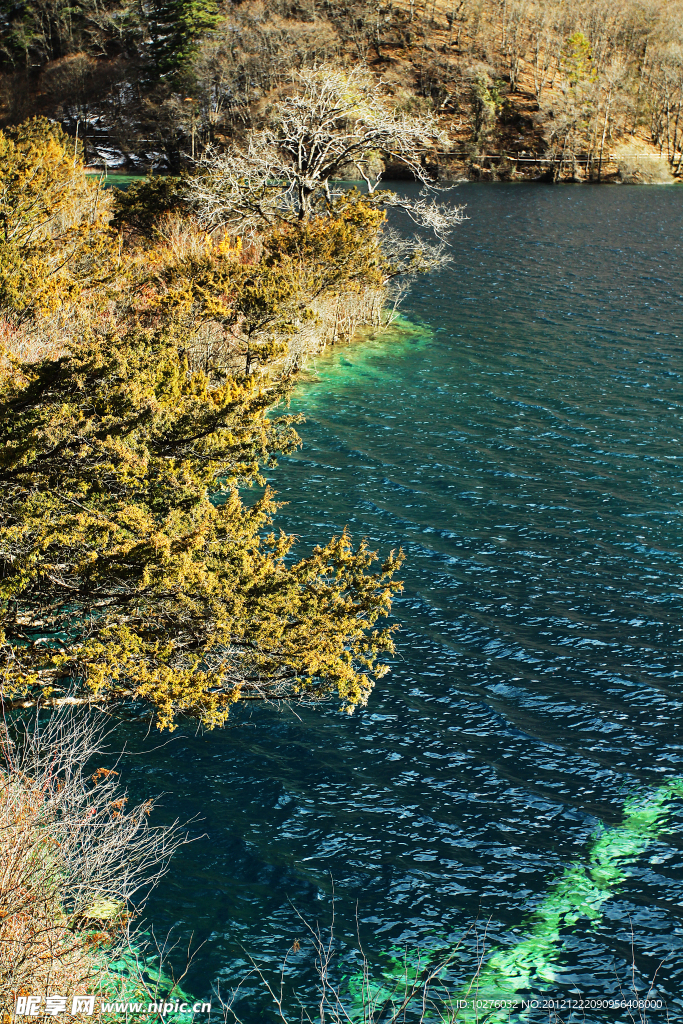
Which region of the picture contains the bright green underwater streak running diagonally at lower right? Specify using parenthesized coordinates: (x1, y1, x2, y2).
(347, 778, 683, 1024)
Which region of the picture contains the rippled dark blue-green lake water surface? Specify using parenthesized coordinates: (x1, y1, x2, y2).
(122, 185, 683, 1024)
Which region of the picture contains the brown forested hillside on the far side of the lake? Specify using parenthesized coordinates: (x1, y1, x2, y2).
(0, 0, 683, 178)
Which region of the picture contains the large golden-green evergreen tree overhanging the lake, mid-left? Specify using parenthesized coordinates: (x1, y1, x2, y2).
(0, 330, 400, 727)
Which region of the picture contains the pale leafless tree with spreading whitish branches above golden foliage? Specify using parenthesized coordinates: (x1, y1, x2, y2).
(187, 66, 462, 232)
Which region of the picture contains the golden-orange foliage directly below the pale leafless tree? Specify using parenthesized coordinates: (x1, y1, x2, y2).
(138, 190, 390, 373)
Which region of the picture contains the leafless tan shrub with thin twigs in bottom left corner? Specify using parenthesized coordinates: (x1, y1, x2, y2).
(0, 711, 184, 1011)
